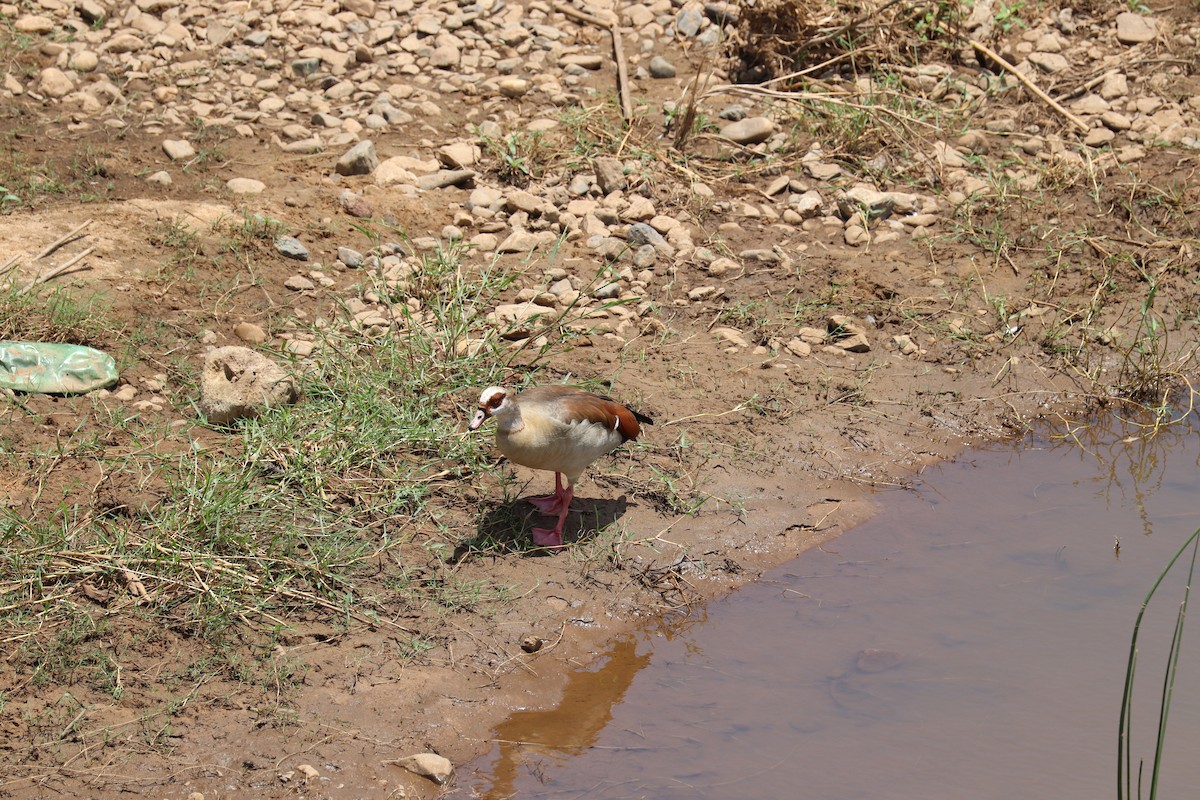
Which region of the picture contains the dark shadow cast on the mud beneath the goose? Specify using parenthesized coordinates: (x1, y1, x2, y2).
(450, 495, 629, 564)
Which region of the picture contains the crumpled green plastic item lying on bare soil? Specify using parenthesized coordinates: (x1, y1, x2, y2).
(0, 342, 119, 395)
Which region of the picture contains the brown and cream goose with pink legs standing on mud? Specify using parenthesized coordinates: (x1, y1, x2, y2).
(470, 386, 654, 547)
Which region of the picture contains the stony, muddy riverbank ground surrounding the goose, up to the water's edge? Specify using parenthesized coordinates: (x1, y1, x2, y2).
(0, 0, 1200, 798)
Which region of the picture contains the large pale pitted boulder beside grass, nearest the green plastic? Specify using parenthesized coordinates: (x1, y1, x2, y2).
(199, 347, 299, 425)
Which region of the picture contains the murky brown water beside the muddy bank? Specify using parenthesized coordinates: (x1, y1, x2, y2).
(458, 420, 1200, 800)
